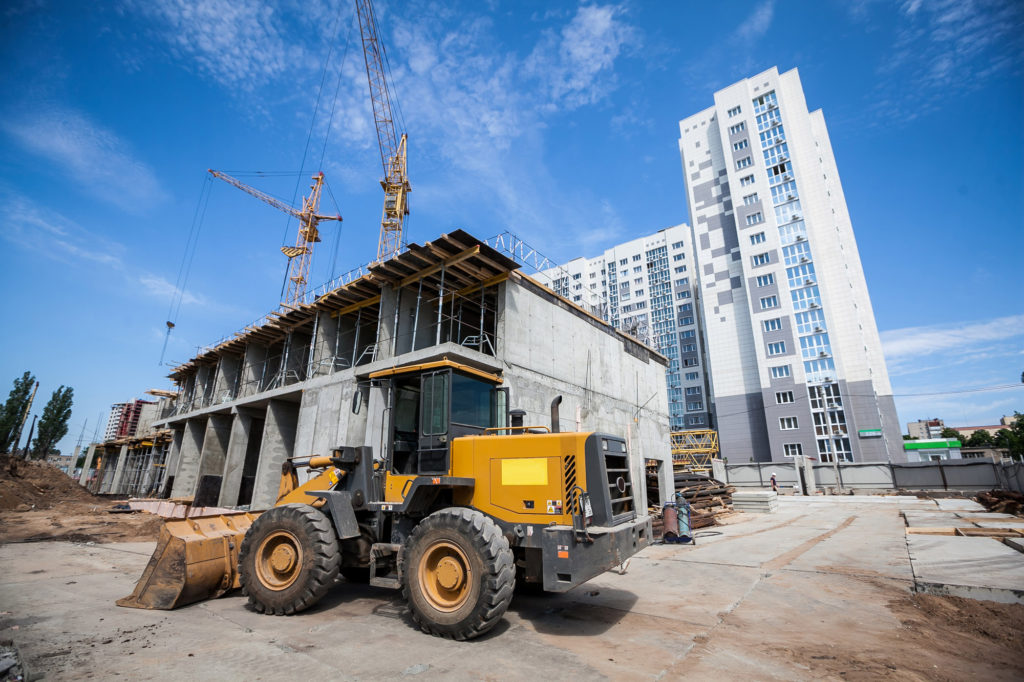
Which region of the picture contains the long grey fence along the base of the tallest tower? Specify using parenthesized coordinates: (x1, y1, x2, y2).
(714, 459, 1024, 493)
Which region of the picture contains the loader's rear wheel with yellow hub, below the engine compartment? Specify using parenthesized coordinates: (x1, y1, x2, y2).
(401, 507, 515, 640)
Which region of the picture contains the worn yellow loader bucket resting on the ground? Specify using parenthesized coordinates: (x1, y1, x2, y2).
(117, 512, 258, 610)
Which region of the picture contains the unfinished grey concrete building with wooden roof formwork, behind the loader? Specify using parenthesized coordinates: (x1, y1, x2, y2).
(86, 230, 672, 510)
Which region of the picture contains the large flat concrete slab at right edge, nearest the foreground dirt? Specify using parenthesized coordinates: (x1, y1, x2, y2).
(906, 536, 1024, 604)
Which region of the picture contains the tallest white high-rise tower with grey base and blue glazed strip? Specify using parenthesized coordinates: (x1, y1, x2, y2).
(679, 68, 902, 462)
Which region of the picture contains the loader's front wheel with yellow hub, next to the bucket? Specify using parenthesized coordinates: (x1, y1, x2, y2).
(239, 504, 340, 615)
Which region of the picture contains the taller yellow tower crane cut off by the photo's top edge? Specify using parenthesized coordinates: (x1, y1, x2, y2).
(355, 0, 412, 262)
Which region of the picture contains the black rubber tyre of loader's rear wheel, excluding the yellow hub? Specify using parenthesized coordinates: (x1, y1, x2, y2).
(401, 507, 515, 641)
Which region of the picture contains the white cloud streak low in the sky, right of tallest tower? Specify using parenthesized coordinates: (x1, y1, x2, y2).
(881, 315, 1024, 359)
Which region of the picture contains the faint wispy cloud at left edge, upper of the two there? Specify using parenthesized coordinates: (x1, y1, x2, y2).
(2, 106, 166, 212)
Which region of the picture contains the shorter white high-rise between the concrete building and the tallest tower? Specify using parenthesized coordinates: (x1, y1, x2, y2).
(542, 224, 711, 431)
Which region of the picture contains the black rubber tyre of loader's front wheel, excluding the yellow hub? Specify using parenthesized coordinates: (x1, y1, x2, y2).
(239, 504, 340, 615)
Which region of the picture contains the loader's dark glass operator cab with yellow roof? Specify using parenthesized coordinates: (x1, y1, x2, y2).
(371, 359, 508, 476)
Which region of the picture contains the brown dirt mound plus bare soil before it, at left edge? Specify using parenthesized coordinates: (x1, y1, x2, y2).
(0, 456, 163, 544)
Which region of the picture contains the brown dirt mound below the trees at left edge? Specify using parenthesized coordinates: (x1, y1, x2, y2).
(0, 455, 97, 510)
